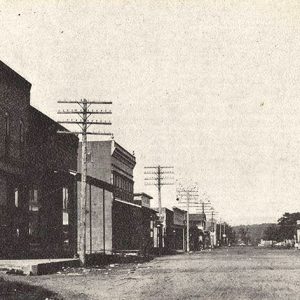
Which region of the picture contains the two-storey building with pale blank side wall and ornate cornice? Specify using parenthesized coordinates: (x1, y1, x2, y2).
(78, 140, 138, 253)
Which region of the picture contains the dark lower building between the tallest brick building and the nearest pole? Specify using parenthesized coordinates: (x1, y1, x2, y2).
(26, 107, 78, 255)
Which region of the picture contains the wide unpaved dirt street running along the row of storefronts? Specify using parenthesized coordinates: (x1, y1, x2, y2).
(4, 248, 300, 300)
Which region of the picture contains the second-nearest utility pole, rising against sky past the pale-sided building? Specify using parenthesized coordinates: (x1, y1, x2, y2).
(144, 165, 174, 221)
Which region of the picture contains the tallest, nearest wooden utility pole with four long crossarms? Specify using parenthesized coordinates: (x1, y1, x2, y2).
(58, 99, 112, 265)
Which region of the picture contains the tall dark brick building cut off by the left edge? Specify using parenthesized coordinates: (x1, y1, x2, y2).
(0, 61, 31, 256)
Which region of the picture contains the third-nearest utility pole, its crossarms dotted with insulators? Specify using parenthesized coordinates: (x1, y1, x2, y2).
(177, 185, 199, 252)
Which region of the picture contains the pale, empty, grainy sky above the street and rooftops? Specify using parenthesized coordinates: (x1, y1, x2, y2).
(0, 0, 300, 224)
